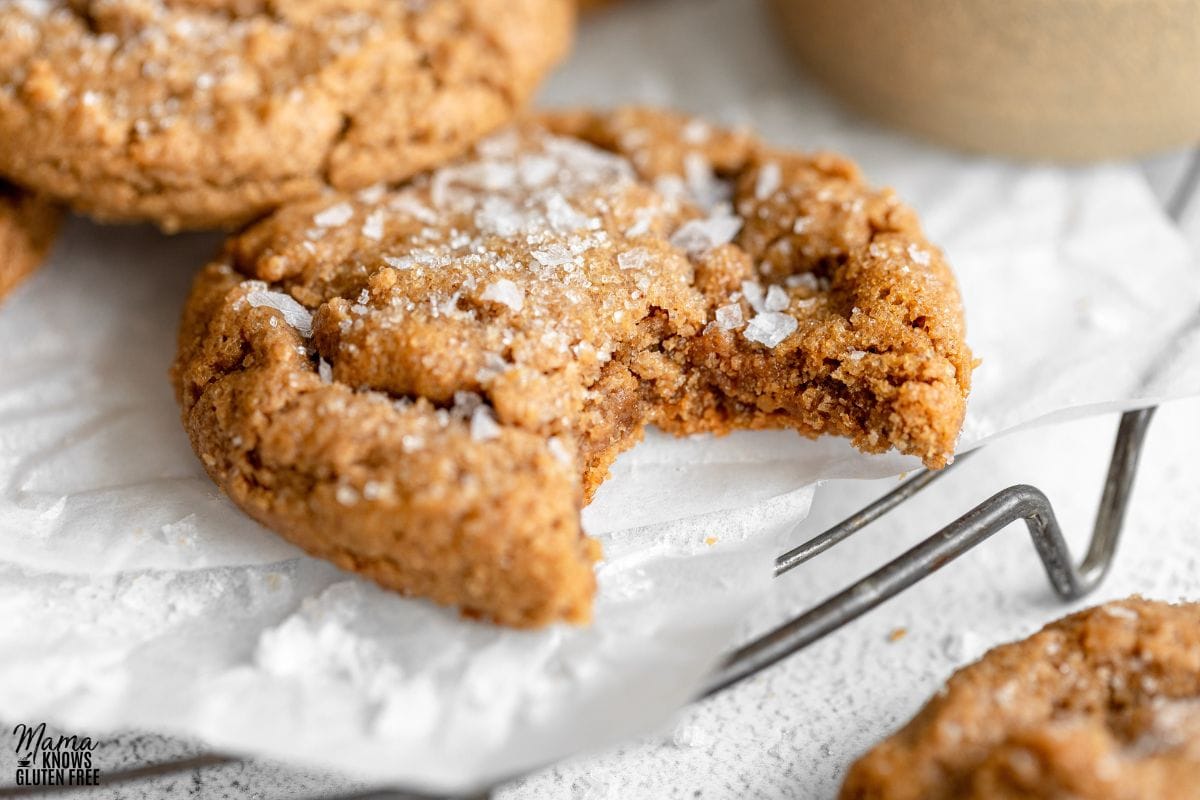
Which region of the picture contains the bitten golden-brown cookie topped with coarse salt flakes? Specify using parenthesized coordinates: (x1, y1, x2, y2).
(173, 109, 972, 626)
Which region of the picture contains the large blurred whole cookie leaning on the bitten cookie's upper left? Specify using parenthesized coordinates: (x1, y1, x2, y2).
(0, 0, 575, 230)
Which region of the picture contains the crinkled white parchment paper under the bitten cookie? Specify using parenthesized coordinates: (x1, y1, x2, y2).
(0, 0, 1200, 790)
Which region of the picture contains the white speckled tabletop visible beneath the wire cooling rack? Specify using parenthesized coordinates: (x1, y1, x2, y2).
(7, 401, 1200, 800)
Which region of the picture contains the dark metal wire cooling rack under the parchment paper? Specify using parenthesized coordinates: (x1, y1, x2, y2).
(0, 148, 1200, 800)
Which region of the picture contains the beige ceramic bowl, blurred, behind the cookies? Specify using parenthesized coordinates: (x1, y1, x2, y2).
(770, 0, 1200, 161)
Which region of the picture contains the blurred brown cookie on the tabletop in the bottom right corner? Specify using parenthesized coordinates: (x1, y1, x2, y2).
(840, 597, 1200, 800)
